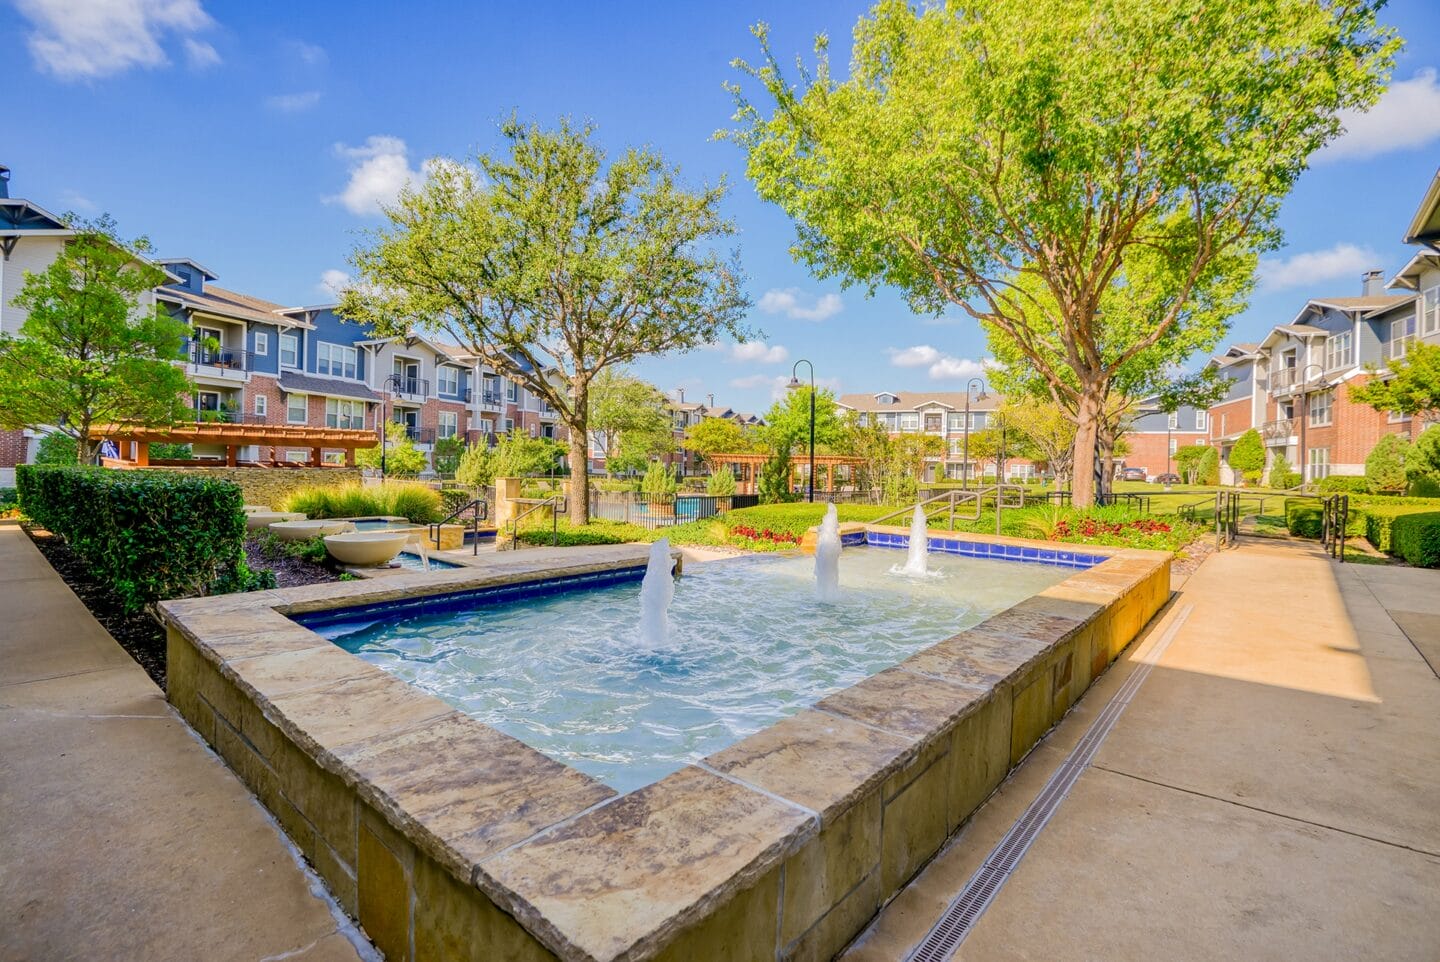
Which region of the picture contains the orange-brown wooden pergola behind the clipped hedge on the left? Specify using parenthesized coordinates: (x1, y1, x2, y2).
(95, 422, 380, 468)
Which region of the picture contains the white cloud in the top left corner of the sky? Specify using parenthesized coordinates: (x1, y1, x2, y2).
(16, 0, 220, 81)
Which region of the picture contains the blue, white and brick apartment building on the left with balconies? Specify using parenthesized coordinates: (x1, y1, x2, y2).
(0, 168, 564, 469)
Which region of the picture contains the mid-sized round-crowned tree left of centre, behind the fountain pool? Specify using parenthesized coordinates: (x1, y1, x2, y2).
(341, 121, 749, 524)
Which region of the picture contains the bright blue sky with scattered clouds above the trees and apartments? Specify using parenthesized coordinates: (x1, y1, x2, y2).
(11, 0, 1440, 409)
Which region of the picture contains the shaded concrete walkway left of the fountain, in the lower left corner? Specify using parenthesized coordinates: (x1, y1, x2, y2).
(0, 527, 376, 962)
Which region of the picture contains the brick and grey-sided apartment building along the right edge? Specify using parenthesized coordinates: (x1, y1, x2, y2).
(1208, 173, 1440, 482)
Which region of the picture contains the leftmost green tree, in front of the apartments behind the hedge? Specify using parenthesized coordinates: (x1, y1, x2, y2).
(0, 217, 190, 464)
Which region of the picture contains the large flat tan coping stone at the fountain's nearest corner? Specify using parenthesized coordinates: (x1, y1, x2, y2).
(477, 768, 818, 962)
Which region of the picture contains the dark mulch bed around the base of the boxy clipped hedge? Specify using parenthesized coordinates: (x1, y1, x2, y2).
(24, 526, 340, 688)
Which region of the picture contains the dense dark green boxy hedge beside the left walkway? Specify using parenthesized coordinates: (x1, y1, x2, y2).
(17, 465, 248, 612)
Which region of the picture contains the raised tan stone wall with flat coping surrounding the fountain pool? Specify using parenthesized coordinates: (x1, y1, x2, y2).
(163, 541, 1169, 962)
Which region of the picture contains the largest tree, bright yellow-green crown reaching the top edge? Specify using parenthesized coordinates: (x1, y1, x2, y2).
(730, 0, 1400, 507)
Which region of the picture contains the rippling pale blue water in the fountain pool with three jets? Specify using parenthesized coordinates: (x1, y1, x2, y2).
(336, 549, 1073, 791)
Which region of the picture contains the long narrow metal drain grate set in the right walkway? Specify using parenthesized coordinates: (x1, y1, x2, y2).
(906, 605, 1191, 962)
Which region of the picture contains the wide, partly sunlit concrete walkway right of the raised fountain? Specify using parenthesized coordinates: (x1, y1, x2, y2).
(844, 543, 1440, 962)
